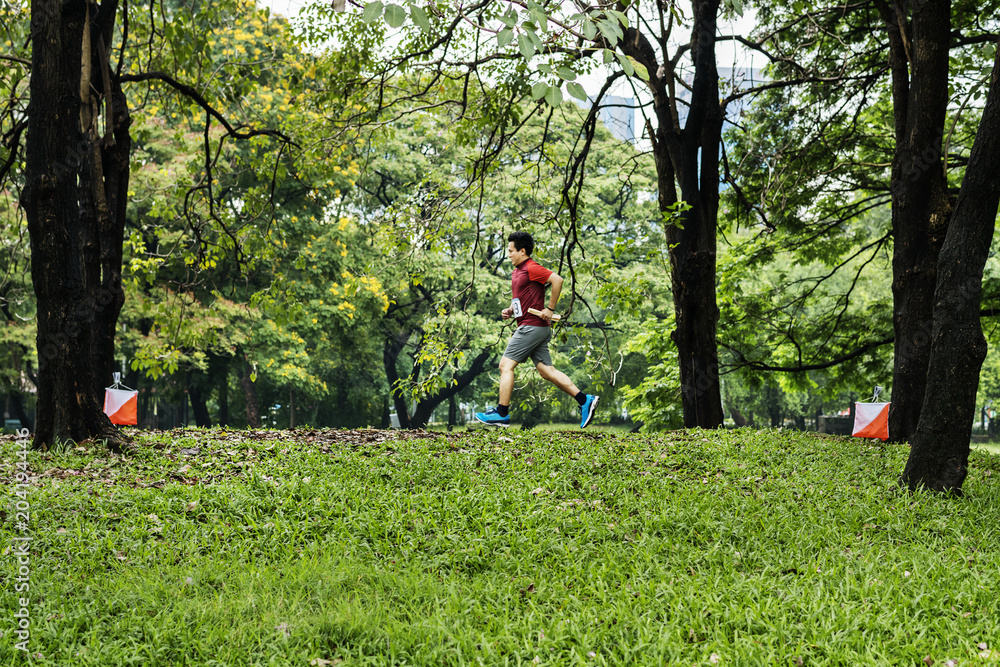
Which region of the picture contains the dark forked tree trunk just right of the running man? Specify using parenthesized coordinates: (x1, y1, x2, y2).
(620, 0, 725, 428)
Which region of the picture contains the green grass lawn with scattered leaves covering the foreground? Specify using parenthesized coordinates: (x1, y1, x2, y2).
(0, 429, 1000, 667)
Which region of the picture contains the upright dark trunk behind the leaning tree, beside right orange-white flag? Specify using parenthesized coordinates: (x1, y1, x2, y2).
(879, 0, 952, 440)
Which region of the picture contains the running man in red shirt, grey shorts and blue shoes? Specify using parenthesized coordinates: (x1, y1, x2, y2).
(476, 232, 599, 428)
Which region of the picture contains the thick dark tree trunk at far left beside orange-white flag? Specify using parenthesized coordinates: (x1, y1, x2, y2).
(21, 0, 130, 451)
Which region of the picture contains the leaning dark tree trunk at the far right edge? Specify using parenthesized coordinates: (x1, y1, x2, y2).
(902, 43, 1000, 493)
